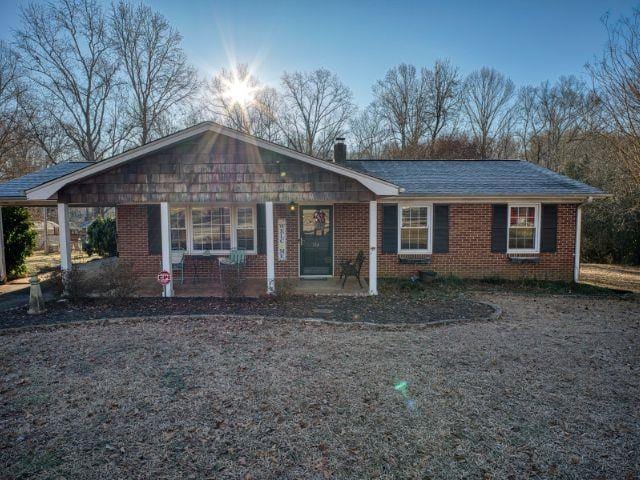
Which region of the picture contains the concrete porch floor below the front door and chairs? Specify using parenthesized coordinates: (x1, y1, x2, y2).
(139, 277, 369, 298)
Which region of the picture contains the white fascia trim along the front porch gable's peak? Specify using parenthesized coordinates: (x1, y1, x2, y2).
(26, 122, 399, 200)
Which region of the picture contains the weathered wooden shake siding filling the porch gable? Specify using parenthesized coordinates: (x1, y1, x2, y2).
(59, 133, 374, 205)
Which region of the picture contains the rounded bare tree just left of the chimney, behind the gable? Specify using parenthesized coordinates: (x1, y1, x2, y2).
(277, 69, 354, 159)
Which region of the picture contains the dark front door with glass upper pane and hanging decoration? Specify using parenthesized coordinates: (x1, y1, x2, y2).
(300, 205, 333, 276)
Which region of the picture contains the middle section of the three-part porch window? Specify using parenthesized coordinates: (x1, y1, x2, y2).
(191, 207, 231, 251)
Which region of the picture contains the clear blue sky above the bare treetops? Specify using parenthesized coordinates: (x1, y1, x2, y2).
(0, 0, 640, 106)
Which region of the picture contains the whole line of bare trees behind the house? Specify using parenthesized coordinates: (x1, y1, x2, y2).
(0, 0, 640, 263)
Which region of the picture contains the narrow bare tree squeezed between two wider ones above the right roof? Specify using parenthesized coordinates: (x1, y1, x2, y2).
(424, 60, 460, 149)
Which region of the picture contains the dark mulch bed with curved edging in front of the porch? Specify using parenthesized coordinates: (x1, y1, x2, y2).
(0, 294, 493, 329)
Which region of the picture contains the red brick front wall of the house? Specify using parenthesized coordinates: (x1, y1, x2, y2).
(117, 203, 576, 280)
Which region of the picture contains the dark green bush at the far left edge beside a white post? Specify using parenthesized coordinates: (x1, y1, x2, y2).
(2, 207, 36, 278)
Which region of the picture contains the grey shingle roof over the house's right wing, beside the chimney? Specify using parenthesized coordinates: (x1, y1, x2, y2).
(344, 160, 604, 196)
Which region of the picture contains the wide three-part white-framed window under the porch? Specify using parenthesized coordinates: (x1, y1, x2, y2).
(171, 205, 257, 253)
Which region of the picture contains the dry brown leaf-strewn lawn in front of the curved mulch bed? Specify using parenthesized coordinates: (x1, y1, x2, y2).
(0, 294, 640, 479)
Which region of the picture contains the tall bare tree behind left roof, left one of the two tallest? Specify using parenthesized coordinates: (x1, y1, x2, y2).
(16, 0, 125, 161)
